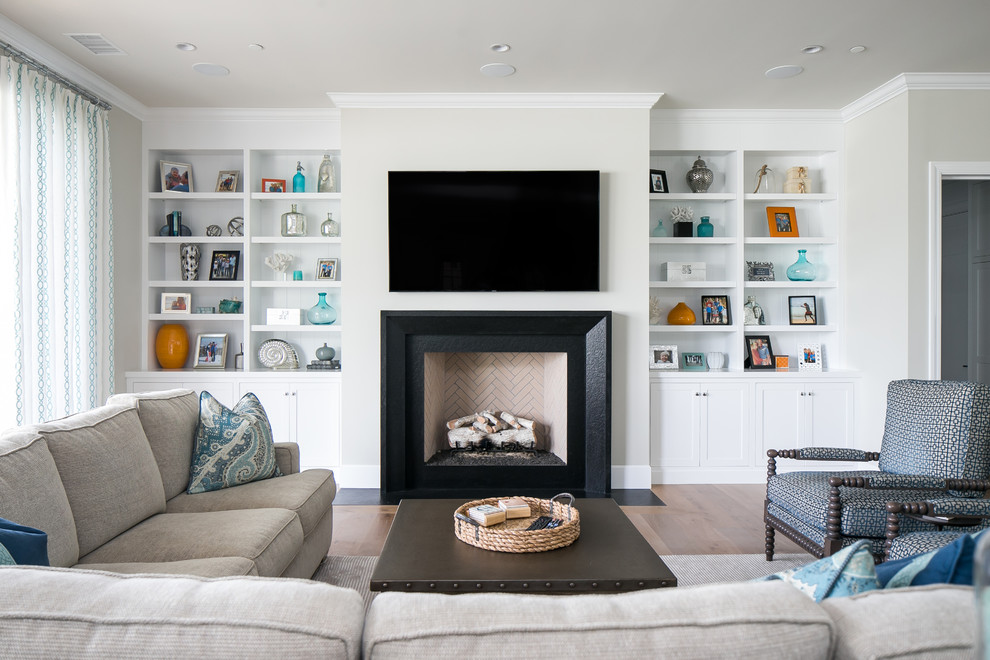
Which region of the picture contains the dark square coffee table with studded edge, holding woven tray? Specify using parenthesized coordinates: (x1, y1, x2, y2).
(371, 498, 677, 594)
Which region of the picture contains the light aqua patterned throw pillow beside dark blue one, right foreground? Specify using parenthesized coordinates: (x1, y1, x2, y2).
(761, 540, 880, 603)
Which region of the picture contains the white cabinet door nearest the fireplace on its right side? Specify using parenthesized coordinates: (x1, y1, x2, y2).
(650, 383, 701, 467)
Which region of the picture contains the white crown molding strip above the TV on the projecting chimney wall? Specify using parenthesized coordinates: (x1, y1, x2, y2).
(327, 92, 663, 109)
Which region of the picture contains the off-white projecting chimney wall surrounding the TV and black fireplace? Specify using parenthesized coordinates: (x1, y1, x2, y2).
(341, 109, 650, 488)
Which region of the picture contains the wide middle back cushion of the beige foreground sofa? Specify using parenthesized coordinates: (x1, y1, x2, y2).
(363, 582, 832, 660)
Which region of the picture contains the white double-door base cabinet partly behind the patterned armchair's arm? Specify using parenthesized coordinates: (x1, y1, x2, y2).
(756, 380, 855, 456)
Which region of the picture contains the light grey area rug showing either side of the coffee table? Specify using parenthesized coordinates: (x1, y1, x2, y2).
(313, 554, 814, 608)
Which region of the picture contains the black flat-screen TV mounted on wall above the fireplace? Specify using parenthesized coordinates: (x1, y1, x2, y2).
(388, 170, 601, 291)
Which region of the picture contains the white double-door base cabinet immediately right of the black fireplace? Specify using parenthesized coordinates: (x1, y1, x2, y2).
(650, 381, 752, 467)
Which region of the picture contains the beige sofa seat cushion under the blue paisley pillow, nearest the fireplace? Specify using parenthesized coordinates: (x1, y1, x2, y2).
(166, 469, 337, 536)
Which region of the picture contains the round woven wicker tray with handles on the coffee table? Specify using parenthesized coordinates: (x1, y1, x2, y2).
(454, 494, 581, 552)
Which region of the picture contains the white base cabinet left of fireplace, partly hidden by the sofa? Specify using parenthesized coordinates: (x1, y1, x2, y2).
(240, 379, 341, 469)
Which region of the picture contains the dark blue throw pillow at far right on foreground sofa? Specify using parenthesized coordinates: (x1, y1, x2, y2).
(877, 532, 985, 589)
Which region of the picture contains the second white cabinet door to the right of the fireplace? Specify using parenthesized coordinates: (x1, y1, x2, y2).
(701, 383, 753, 467)
